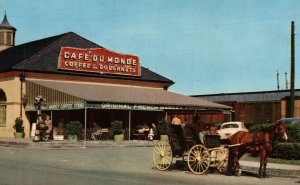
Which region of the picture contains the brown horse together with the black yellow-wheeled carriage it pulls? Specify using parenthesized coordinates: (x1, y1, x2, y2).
(153, 123, 288, 177)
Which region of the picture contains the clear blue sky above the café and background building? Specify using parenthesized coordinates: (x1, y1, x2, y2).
(0, 0, 300, 95)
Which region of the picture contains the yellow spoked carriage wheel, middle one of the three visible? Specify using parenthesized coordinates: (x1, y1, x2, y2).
(187, 145, 210, 175)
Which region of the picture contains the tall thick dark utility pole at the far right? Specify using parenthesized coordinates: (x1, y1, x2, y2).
(290, 21, 295, 117)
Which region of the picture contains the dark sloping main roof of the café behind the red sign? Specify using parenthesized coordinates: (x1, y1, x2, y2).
(0, 32, 174, 85)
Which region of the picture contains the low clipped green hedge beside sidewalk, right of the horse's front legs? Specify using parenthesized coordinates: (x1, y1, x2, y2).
(271, 143, 300, 160)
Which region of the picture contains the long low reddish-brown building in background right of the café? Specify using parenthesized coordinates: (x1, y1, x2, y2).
(192, 89, 300, 124)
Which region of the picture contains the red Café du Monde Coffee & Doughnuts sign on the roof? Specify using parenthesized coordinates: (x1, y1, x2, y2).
(57, 47, 141, 77)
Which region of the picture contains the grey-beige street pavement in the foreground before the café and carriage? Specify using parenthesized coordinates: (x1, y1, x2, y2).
(0, 144, 300, 185)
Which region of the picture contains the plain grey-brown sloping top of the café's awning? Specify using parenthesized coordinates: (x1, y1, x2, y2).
(29, 80, 231, 110)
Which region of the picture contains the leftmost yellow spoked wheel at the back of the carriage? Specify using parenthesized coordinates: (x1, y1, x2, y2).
(153, 141, 173, 171)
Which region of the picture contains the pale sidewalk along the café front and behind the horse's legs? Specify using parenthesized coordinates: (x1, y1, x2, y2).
(0, 138, 300, 170)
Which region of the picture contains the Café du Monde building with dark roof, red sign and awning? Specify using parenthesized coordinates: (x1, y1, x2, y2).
(0, 15, 231, 139)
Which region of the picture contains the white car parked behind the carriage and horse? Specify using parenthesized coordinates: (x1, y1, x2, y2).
(218, 121, 249, 139)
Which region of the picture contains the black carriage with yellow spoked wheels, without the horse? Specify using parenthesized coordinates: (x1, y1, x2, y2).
(153, 125, 229, 174)
